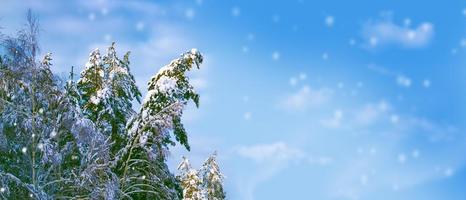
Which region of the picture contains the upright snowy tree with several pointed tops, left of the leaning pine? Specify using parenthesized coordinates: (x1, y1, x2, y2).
(78, 43, 141, 153)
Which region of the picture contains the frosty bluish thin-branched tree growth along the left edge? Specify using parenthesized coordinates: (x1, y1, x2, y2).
(0, 12, 118, 199)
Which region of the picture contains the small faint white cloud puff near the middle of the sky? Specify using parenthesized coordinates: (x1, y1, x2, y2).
(280, 85, 333, 110)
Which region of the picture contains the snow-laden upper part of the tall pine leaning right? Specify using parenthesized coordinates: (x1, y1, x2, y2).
(130, 49, 203, 153)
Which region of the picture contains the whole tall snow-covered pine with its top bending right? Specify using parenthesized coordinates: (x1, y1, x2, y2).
(118, 49, 202, 199)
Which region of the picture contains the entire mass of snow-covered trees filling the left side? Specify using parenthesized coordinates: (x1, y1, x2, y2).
(0, 13, 223, 200)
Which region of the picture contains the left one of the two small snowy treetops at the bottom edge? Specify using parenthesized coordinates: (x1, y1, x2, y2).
(178, 157, 206, 200)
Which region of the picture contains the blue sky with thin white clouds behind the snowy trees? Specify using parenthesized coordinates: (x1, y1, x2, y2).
(0, 0, 466, 200)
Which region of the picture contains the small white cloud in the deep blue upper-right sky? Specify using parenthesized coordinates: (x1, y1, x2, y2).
(362, 17, 434, 48)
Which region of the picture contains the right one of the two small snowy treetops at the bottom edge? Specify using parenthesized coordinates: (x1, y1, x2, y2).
(199, 152, 225, 200)
